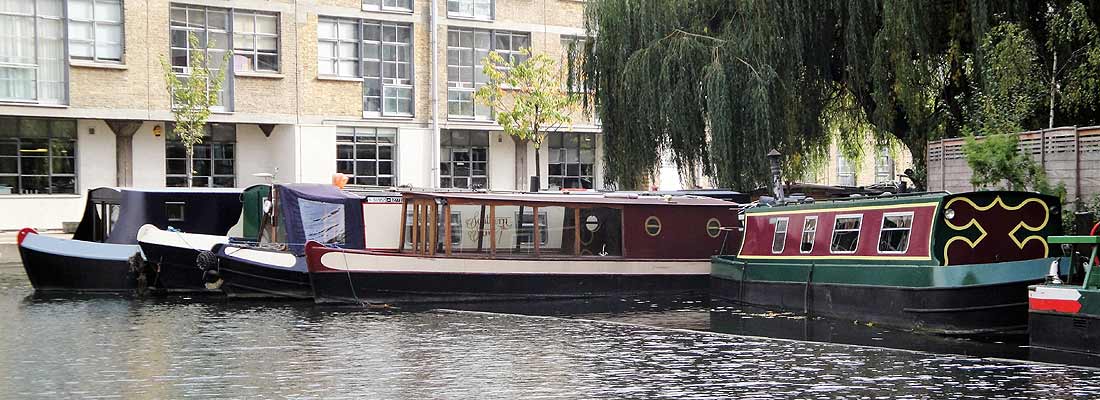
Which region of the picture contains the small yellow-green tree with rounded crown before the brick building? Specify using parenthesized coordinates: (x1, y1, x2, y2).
(474, 48, 580, 190)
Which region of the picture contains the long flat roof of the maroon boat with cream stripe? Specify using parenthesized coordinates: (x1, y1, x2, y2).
(405, 192, 737, 207)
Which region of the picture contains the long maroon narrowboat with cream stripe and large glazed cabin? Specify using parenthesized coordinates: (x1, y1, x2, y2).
(306, 192, 737, 303)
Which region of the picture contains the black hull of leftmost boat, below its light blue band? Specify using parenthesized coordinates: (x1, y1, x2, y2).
(19, 246, 139, 293)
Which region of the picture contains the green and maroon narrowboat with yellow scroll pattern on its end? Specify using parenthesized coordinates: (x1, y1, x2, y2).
(711, 191, 1062, 334)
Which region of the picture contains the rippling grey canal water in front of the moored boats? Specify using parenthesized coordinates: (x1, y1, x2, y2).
(0, 260, 1100, 400)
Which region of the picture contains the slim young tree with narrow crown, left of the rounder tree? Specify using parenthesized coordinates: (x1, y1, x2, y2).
(161, 33, 231, 187)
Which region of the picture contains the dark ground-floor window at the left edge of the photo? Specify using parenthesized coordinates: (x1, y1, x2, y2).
(0, 118, 76, 195)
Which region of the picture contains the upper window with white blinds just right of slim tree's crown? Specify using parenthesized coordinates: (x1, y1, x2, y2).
(233, 10, 278, 73)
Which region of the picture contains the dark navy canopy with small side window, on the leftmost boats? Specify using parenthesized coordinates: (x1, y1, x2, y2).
(73, 188, 241, 244)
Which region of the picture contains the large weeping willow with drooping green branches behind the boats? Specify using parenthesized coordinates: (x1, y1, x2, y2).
(589, 0, 1100, 189)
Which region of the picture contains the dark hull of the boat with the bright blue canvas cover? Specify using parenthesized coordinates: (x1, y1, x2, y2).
(218, 255, 314, 300)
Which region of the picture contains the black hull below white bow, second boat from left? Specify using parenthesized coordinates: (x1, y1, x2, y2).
(141, 243, 212, 295)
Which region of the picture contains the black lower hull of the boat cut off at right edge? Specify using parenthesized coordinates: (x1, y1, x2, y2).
(1029, 311, 1100, 356)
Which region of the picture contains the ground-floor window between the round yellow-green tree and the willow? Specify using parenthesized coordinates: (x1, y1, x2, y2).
(547, 133, 596, 189)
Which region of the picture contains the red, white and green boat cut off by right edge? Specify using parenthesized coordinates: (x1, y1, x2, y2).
(1027, 229, 1100, 355)
